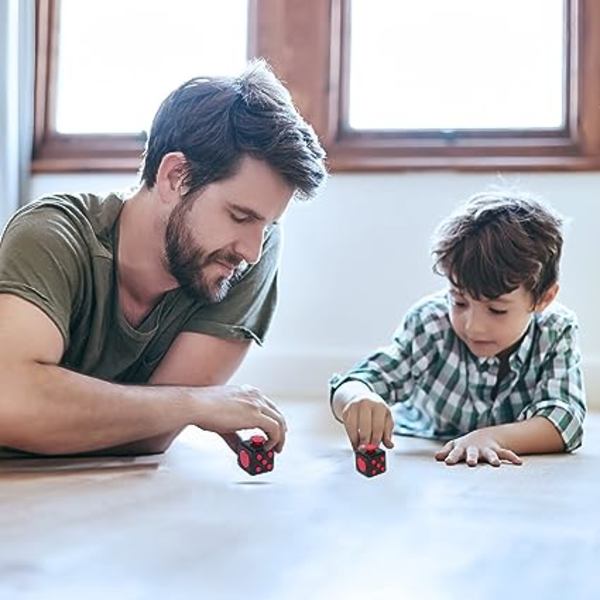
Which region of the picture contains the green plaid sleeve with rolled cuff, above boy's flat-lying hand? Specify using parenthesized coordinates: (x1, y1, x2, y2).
(517, 324, 586, 452)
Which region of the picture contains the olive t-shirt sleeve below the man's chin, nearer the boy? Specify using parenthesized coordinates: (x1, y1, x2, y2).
(183, 225, 282, 345)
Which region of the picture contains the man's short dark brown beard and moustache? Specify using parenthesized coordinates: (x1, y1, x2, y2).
(165, 202, 246, 303)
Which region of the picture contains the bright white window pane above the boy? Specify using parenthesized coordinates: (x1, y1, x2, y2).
(349, 0, 566, 130)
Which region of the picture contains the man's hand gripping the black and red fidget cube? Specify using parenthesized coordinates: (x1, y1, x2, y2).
(191, 385, 287, 452)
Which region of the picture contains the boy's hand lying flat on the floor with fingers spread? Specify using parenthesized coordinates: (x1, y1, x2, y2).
(435, 429, 523, 467)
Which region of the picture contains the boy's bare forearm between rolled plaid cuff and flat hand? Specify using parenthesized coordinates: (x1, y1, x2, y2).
(489, 417, 565, 454)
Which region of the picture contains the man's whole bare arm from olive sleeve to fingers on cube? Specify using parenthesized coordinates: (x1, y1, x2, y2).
(0, 294, 283, 454)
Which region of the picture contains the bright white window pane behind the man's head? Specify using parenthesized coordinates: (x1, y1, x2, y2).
(55, 0, 248, 134)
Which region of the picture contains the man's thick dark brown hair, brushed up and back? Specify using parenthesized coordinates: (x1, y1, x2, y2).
(141, 60, 326, 198)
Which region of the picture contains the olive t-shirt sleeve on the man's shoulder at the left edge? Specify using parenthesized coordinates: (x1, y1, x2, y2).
(0, 206, 83, 348)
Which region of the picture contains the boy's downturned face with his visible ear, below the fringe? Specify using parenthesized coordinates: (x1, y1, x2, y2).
(450, 284, 558, 358)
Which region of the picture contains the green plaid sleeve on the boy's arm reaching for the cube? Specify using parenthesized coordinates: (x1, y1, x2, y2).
(329, 311, 432, 405)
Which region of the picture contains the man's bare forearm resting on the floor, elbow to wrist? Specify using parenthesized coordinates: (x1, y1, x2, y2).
(0, 363, 199, 454)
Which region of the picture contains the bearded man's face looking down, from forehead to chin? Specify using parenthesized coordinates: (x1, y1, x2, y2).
(165, 157, 293, 302)
